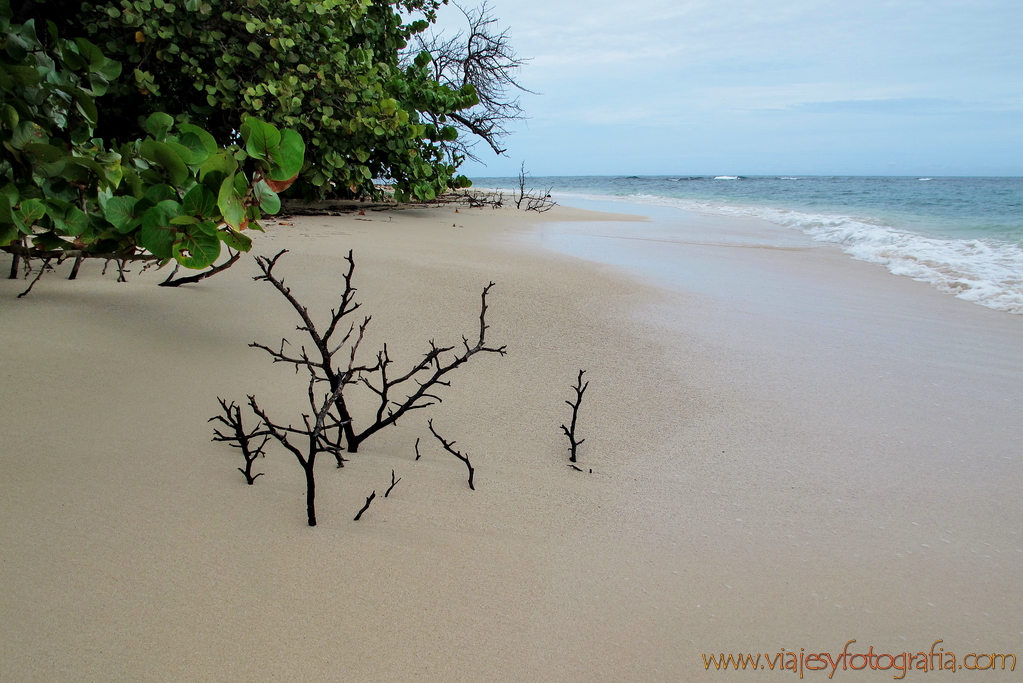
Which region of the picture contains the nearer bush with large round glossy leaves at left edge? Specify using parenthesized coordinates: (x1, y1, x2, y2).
(0, 0, 304, 269)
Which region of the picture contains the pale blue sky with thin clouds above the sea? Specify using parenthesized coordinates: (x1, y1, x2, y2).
(423, 0, 1023, 178)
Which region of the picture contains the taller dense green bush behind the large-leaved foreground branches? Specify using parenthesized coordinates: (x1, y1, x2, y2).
(58, 0, 478, 200)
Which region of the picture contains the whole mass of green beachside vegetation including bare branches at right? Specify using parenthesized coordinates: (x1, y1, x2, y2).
(0, 0, 522, 288)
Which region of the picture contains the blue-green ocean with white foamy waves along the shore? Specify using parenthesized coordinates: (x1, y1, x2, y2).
(473, 176, 1023, 314)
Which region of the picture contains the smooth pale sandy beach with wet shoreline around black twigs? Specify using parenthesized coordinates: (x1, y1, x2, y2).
(0, 200, 1023, 683)
